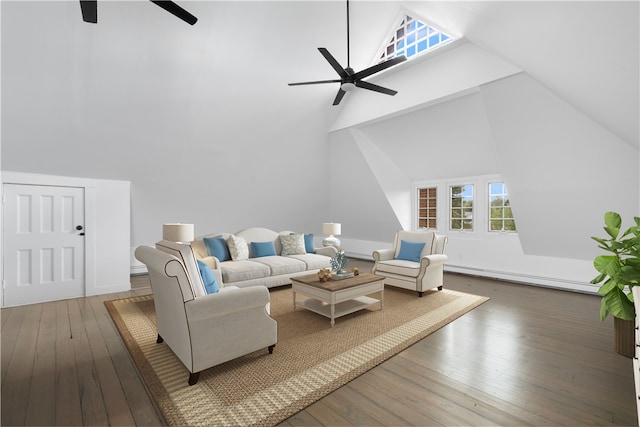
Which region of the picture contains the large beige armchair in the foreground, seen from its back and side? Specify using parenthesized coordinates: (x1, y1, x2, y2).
(135, 244, 278, 385)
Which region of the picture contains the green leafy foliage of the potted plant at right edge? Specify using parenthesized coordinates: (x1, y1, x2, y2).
(591, 212, 640, 320)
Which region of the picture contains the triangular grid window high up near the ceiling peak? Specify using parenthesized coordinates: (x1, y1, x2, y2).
(378, 15, 453, 62)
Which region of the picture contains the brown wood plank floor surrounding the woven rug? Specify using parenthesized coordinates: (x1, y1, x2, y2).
(0, 261, 637, 426)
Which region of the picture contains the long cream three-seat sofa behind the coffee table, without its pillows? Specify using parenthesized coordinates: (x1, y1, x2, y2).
(191, 227, 338, 288)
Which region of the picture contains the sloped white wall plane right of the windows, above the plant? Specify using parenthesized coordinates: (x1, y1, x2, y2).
(481, 74, 640, 260)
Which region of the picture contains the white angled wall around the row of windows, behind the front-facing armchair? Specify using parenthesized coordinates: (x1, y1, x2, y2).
(331, 73, 640, 292)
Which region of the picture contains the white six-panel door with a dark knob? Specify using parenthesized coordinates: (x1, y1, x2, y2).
(3, 184, 84, 306)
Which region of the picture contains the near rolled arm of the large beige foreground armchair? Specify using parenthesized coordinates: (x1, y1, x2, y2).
(185, 286, 269, 322)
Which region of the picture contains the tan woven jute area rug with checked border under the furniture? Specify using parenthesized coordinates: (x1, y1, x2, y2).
(105, 287, 488, 426)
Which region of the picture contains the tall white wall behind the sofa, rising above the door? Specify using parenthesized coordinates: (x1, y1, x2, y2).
(1, 1, 335, 265)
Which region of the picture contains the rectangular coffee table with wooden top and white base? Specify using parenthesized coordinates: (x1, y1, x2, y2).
(291, 274, 384, 327)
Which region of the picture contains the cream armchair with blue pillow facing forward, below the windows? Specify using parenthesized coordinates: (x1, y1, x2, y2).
(371, 231, 447, 297)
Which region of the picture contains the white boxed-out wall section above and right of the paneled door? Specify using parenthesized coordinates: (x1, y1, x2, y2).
(2, 171, 131, 302)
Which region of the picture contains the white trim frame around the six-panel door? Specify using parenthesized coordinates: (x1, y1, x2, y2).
(0, 171, 96, 307)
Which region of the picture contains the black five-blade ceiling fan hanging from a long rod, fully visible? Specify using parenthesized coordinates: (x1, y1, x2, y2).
(289, 0, 407, 105)
